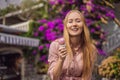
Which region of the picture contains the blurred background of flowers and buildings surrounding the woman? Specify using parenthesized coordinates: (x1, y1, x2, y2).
(0, 0, 120, 80)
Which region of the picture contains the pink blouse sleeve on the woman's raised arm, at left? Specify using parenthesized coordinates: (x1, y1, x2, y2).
(47, 41, 59, 80)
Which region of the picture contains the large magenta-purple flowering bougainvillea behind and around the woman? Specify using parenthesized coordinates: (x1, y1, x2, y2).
(21, 0, 120, 73)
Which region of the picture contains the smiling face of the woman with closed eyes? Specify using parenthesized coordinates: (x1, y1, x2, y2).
(66, 12, 83, 37)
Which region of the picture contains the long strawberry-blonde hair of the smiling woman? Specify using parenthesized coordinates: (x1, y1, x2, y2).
(63, 10, 96, 80)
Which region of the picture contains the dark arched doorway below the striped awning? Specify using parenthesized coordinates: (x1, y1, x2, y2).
(0, 47, 23, 80)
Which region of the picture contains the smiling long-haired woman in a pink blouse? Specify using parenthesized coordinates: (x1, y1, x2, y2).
(48, 10, 97, 80)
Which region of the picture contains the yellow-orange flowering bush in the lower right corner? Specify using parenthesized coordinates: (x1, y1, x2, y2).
(98, 48, 120, 80)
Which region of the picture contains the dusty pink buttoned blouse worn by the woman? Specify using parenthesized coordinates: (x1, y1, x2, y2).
(48, 40, 83, 80)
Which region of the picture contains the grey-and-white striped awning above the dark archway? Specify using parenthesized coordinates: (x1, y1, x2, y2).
(0, 33, 39, 47)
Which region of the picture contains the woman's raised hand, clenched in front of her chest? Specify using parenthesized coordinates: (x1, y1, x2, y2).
(58, 45, 67, 61)
